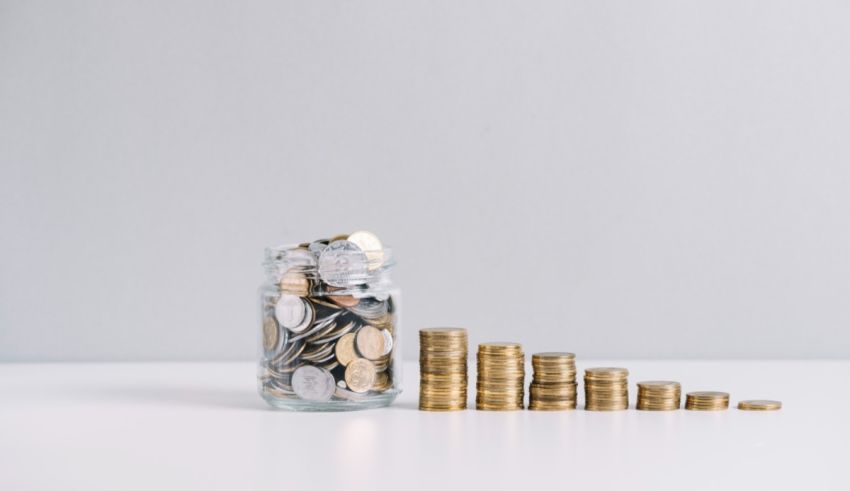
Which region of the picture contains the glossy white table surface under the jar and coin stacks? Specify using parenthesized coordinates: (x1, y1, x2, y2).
(0, 359, 850, 491)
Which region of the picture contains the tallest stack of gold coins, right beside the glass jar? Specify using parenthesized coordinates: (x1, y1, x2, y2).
(419, 327, 469, 411)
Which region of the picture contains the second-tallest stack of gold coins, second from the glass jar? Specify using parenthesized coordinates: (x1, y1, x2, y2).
(475, 343, 525, 411)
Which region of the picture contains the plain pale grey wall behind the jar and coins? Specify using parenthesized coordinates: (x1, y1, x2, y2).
(0, 0, 850, 361)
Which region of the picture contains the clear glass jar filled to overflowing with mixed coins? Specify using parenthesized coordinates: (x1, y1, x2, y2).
(258, 232, 401, 411)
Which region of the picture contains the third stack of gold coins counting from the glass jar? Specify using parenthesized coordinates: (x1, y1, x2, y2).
(528, 353, 577, 411)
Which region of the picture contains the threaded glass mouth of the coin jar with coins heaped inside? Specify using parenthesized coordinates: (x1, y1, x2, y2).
(263, 240, 395, 294)
